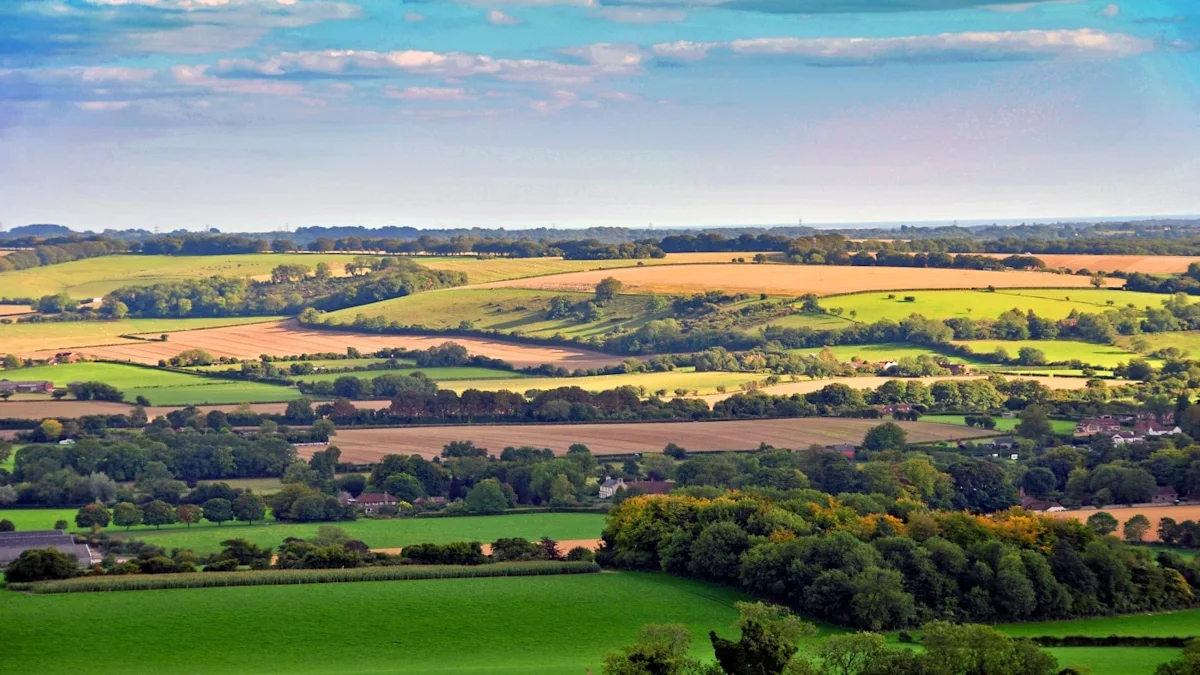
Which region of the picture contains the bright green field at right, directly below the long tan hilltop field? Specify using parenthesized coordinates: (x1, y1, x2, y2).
(821, 288, 1168, 323)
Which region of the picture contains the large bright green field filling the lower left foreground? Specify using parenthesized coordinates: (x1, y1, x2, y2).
(0, 572, 744, 674)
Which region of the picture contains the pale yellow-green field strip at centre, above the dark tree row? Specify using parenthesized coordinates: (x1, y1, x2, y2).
(434, 368, 767, 396)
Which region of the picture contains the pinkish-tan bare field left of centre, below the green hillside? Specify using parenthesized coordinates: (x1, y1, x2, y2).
(26, 319, 620, 369)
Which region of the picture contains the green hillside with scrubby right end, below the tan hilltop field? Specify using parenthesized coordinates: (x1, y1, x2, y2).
(326, 288, 668, 339)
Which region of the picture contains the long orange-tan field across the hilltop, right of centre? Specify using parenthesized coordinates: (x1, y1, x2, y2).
(476, 263, 1123, 295)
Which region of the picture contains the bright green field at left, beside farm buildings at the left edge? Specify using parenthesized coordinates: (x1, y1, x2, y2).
(4, 362, 300, 406)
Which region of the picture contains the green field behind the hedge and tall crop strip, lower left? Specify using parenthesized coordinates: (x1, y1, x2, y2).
(0, 506, 605, 552)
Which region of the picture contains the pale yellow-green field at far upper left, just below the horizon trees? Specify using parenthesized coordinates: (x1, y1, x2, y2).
(0, 253, 374, 299)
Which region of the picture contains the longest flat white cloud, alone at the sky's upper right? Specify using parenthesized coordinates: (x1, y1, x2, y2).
(653, 29, 1154, 66)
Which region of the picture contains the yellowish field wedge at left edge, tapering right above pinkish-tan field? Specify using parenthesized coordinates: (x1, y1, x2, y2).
(0, 316, 283, 354)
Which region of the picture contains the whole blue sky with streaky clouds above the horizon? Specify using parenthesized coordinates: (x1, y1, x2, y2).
(0, 0, 1200, 232)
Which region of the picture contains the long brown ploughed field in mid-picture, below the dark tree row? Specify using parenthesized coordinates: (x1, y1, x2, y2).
(309, 418, 994, 464)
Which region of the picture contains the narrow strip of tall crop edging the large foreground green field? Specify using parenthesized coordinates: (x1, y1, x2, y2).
(7, 561, 600, 593)
